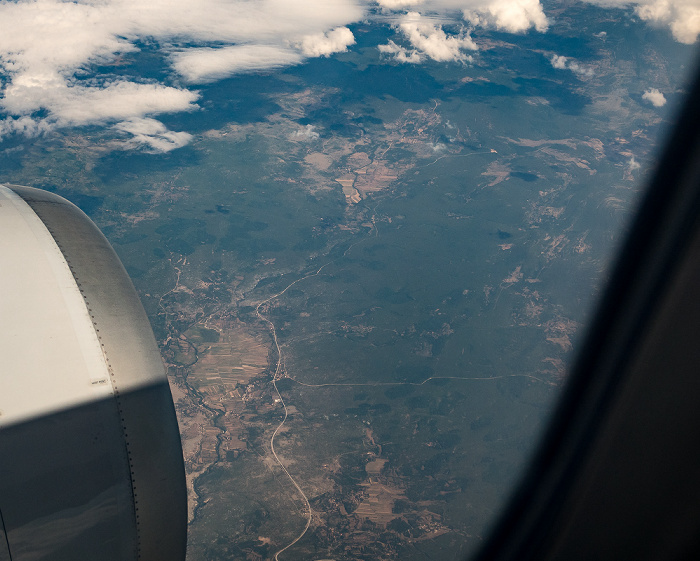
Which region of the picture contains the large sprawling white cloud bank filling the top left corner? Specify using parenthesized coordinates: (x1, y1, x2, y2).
(0, 0, 366, 151)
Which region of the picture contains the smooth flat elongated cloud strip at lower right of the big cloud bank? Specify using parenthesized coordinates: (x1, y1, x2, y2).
(172, 45, 304, 84)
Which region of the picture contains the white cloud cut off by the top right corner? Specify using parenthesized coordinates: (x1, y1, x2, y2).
(586, 0, 700, 45)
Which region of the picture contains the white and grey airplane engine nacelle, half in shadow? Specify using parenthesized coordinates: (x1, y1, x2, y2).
(0, 185, 187, 561)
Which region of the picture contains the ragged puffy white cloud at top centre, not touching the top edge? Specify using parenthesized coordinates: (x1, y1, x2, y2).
(380, 12, 479, 62)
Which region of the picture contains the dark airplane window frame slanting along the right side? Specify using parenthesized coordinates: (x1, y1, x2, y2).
(475, 57, 700, 561)
